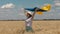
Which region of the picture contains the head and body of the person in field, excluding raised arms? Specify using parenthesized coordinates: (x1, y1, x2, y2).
(25, 12, 33, 31)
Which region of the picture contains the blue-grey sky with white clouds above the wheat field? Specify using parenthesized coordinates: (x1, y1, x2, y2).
(0, 0, 60, 20)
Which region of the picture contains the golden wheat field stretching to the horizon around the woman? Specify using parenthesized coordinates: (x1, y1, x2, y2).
(0, 20, 60, 34)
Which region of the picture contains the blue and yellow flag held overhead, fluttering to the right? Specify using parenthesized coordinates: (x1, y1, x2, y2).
(25, 4, 51, 15)
